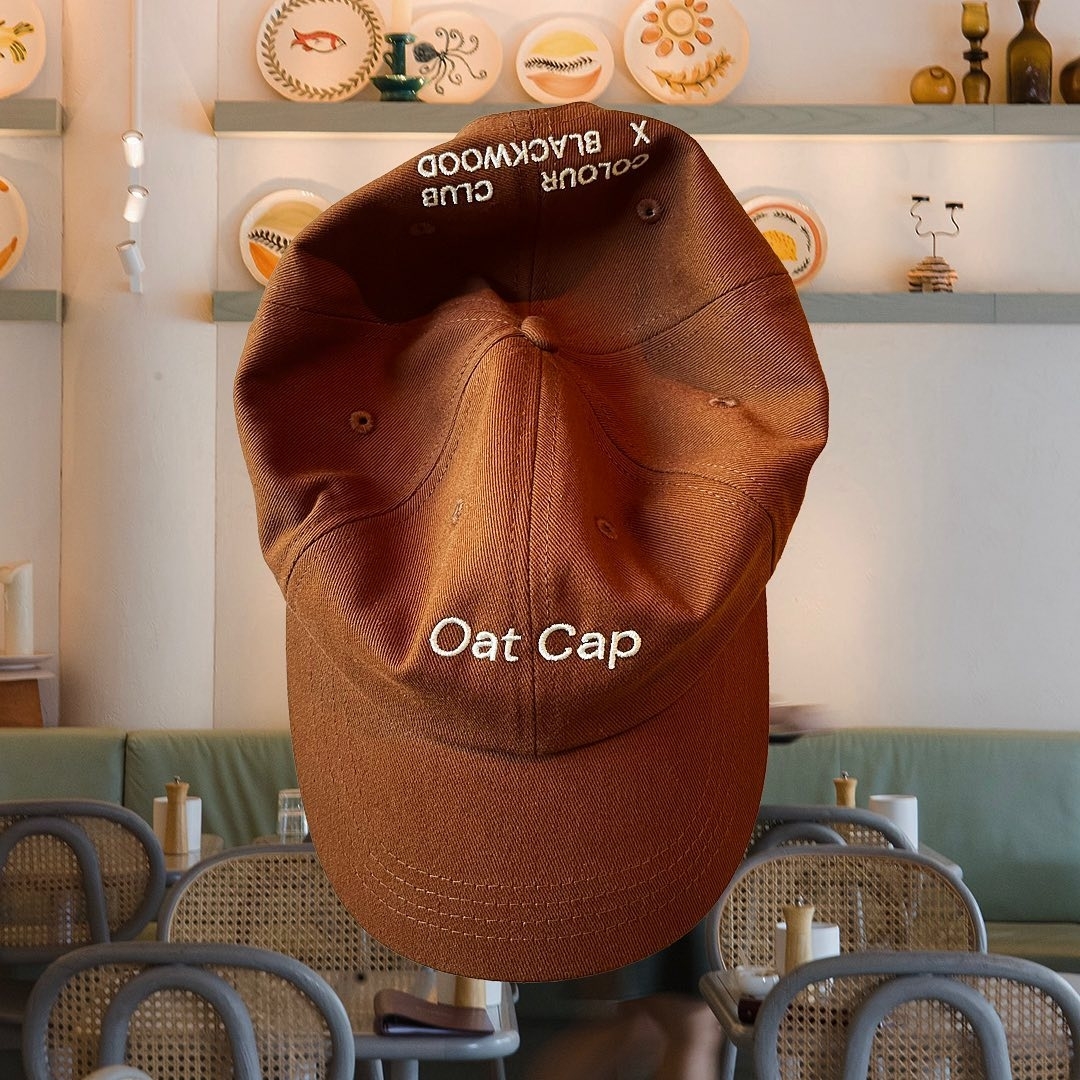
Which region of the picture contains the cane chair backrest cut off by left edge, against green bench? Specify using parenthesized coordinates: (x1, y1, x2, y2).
(0, 799, 165, 964)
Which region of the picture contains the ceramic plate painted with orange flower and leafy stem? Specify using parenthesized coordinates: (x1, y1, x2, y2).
(623, 0, 750, 105)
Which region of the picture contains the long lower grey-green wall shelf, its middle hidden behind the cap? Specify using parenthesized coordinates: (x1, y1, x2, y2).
(214, 289, 1080, 324)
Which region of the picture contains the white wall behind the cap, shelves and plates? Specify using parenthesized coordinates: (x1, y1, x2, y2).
(0, 0, 1080, 728)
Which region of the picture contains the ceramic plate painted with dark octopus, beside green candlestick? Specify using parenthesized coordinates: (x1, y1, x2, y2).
(407, 10, 502, 103)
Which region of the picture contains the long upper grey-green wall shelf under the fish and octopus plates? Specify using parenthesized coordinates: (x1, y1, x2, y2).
(214, 100, 1080, 139)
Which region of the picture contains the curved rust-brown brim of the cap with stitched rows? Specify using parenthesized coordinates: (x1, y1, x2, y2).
(286, 594, 769, 982)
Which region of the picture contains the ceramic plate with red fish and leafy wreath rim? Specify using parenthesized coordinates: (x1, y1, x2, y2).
(255, 0, 383, 102)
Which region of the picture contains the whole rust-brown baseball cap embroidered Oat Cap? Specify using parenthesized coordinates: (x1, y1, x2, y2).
(235, 104, 827, 981)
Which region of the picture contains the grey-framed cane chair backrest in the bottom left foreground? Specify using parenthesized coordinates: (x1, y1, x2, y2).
(23, 942, 355, 1080)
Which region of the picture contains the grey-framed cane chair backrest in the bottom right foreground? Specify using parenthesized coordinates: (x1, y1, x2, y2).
(754, 951, 1080, 1080)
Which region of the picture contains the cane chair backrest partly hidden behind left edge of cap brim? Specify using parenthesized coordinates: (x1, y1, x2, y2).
(158, 843, 420, 987)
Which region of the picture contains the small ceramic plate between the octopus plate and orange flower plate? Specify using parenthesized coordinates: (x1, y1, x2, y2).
(517, 18, 615, 105)
